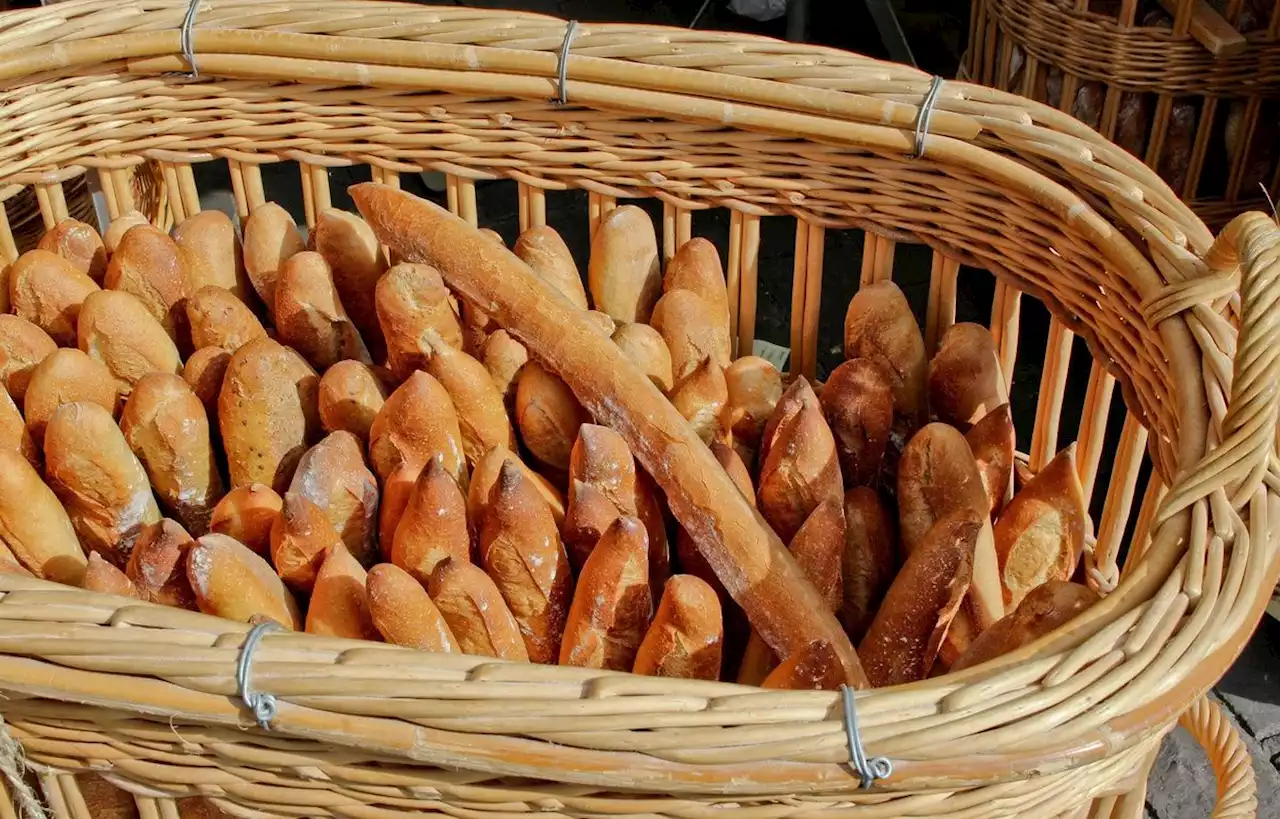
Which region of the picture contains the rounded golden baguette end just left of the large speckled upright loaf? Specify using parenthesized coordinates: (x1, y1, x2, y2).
(120, 372, 223, 536)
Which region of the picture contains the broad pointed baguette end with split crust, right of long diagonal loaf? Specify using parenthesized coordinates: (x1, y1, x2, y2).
(756, 378, 845, 541)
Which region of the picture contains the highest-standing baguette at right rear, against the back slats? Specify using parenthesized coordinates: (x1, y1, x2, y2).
(845, 282, 928, 440)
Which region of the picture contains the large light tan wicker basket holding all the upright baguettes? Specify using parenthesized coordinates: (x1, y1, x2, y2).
(0, 0, 1280, 819)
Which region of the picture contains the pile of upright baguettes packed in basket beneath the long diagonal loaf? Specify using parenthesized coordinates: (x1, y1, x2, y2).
(0, 185, 1096, 688)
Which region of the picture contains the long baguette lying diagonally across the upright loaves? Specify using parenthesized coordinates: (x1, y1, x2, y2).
(351, 183, 867, 687)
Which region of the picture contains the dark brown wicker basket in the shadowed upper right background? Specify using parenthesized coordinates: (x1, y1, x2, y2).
(964, 0, 1280, 228)
